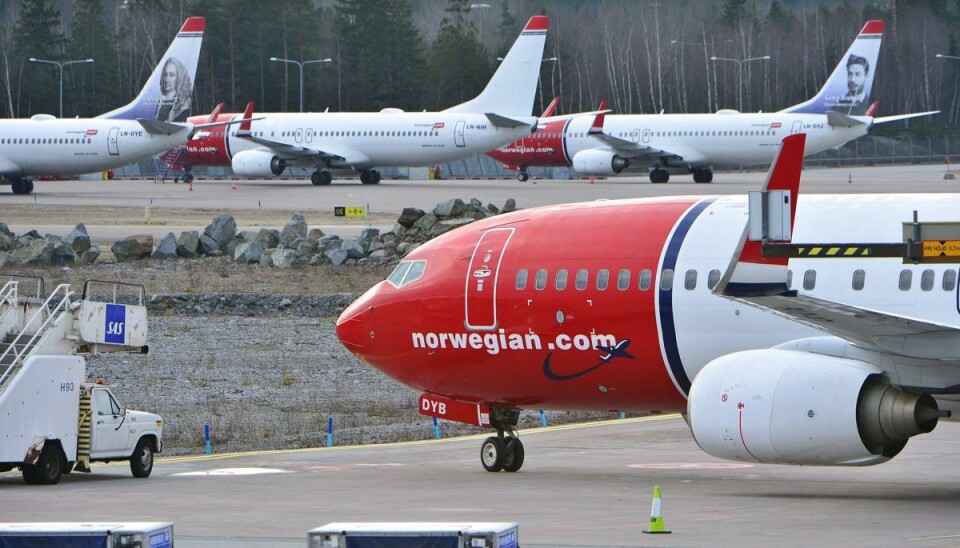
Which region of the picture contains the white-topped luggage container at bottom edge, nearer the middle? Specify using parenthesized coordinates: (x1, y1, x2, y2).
(307, 521, 517, 548)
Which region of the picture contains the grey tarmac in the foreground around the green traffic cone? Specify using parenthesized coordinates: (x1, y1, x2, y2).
(0, 416, 960, 547)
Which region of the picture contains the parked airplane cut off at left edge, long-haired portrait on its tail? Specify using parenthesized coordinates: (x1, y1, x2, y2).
(0, 17, 206, 194)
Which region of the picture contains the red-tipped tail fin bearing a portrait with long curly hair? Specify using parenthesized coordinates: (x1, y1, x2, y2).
(98, 17, 206, 122)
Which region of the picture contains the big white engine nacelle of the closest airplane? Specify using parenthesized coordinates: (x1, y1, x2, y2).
(687, 349, 939, 465)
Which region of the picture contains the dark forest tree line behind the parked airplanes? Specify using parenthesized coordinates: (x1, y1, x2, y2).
(0, 0, 960, 134)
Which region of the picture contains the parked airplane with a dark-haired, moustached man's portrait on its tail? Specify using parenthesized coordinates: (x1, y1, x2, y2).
(488, 20, 939, 183)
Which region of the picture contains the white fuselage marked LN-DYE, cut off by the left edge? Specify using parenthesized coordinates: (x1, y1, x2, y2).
(0, 118, 189, 177)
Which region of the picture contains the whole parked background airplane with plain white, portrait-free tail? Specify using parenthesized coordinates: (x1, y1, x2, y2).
(165, 15, 549, 185)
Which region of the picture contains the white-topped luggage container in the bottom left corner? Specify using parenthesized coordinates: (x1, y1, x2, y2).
(0, 522, 173, 548)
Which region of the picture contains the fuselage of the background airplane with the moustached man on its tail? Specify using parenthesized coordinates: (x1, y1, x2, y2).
(489, 112, 870, 167)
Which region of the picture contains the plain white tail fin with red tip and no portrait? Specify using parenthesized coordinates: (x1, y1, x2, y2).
(445, 15, 550, 116)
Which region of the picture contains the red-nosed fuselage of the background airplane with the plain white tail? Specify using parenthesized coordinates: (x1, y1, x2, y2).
(177, 112, 535, 169)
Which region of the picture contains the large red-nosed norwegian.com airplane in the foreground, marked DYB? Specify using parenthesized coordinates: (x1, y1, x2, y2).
(337, 134, 960, 471)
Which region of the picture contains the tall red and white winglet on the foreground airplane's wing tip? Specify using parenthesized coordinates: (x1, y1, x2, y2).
(713, 133, 807, 297)
